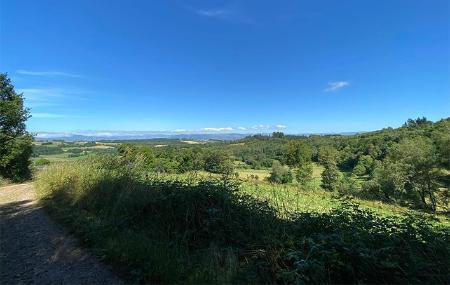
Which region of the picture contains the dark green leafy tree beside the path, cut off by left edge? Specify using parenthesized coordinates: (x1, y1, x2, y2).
(0, 73, 33, 181)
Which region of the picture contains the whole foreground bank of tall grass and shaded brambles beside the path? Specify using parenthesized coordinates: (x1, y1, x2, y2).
(36, 157, 450, 284)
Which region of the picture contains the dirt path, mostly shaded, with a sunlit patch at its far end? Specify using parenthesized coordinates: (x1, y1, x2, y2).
(0, 184, 122, 284)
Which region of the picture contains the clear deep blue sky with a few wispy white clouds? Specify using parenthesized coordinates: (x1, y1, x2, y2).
(0, 0, 450, 133)
